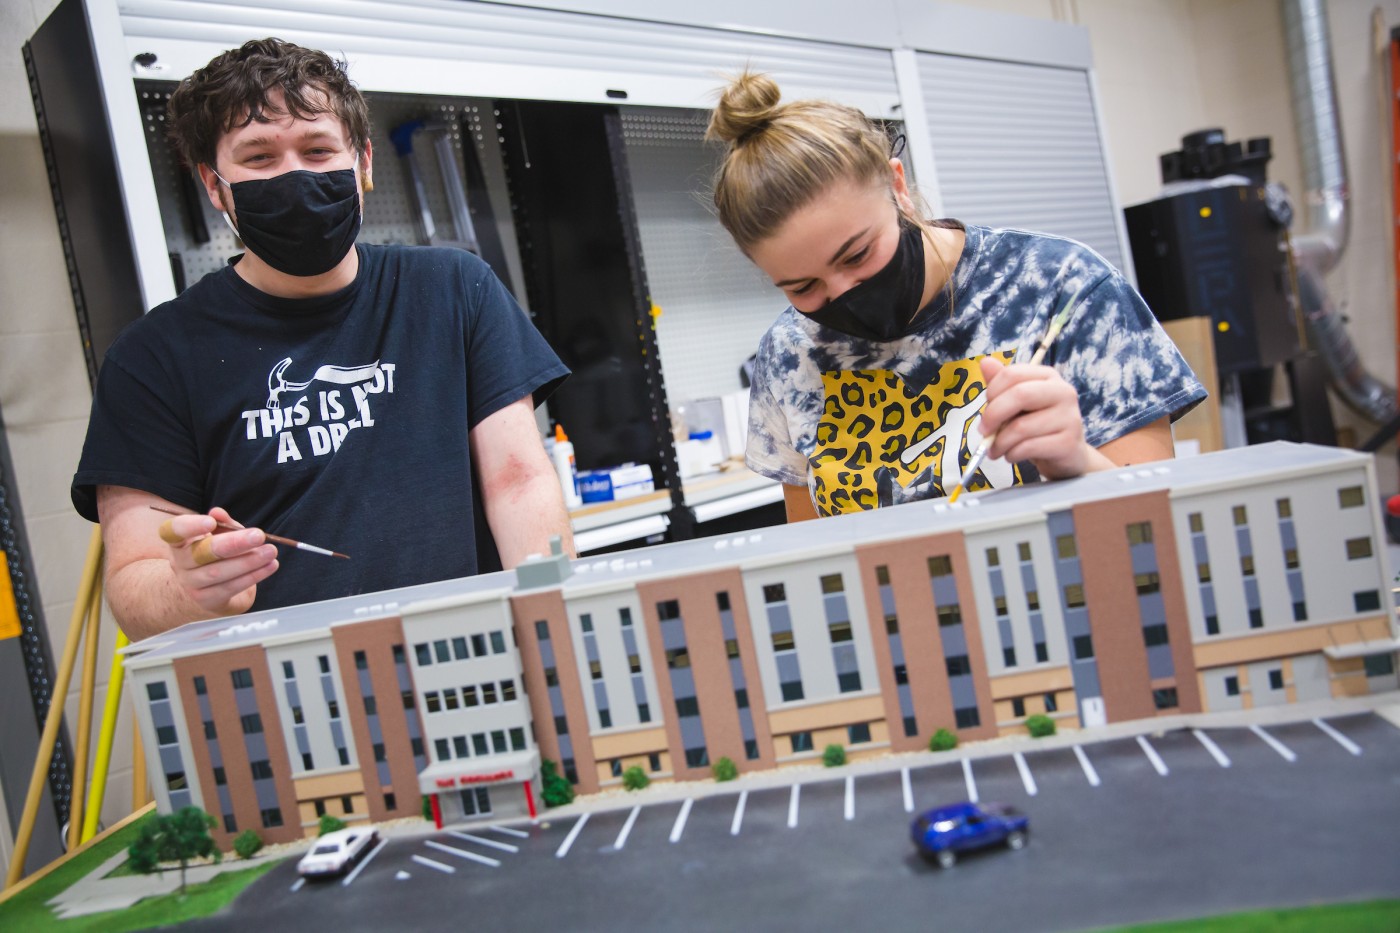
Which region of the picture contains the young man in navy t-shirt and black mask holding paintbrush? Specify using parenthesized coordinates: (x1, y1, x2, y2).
(73, 39, 573, 639)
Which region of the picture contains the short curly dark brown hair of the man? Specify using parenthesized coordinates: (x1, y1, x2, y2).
(167, 38, 370, 167)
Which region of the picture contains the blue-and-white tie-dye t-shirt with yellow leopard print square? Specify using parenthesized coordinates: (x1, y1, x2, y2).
(746, 226, 1205, 516)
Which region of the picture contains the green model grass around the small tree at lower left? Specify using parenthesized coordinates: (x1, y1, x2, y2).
(0, 814, 280, 933)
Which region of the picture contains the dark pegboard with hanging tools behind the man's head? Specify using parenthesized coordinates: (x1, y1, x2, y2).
(137, 81, 524, 298)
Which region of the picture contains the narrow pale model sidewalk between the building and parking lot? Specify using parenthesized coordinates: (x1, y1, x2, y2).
(49, 692, 1400, 919)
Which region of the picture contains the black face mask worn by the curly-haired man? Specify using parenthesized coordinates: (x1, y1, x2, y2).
(216, 158, 360, 276)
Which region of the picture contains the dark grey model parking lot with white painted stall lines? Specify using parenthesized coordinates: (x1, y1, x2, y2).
(182, 713, 1400, 933)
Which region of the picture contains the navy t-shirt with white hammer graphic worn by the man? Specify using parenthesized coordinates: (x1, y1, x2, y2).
(71, 245, 568, 609)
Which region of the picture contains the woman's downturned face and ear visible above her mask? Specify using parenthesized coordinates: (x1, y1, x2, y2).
(749, 158, 913, 314)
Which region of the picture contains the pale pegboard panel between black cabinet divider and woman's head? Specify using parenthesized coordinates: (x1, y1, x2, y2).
(622, 106, 787, 405)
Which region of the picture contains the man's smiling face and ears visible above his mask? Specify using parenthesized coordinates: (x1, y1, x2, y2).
(199, 91, 372, 224)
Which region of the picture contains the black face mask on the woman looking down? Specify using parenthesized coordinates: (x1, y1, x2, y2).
(806, 221, 924, 340)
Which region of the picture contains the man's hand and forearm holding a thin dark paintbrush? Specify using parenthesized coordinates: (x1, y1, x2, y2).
(97, 486, 279, 640)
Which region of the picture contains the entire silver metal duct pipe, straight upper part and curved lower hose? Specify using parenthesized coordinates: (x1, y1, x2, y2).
(1280, 0, 1400, 424)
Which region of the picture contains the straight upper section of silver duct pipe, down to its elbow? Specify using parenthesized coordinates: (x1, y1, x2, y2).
(1281, 0, 1351, 275)
